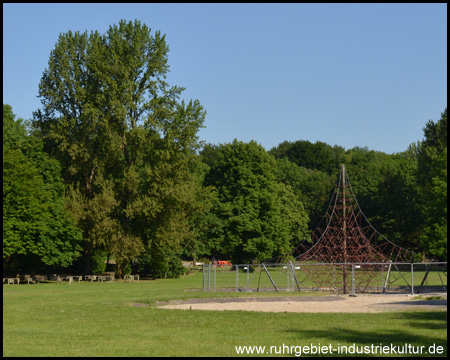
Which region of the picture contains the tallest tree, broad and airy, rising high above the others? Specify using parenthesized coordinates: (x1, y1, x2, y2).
(33, 20, 205, 275)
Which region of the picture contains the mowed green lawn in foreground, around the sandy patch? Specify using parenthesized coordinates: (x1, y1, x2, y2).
(3, 273, 447, 357)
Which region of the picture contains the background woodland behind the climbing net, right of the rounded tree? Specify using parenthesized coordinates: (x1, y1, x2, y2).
(268, 119, 447, 259)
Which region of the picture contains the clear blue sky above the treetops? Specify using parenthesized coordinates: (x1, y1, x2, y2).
(3, 3, 447, 153)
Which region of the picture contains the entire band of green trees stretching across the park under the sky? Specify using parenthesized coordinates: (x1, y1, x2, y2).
(3, 21, 447, 277)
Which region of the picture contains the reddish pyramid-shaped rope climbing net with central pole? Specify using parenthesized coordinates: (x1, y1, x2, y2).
(268, 165, 414, 294)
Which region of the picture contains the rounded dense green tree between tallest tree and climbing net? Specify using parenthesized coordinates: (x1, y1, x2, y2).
(205, 140, 308, 263)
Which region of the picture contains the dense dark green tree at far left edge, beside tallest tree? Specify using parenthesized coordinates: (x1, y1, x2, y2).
(3, 104, 81, 273)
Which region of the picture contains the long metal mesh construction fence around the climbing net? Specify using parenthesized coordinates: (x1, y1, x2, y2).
(203, 262, 447, 294)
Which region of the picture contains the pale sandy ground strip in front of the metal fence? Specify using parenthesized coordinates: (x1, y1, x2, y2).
(157, 294, 447, 313)
